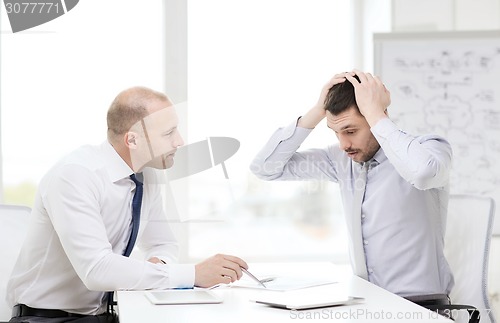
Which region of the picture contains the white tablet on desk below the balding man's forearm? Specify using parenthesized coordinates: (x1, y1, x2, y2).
(145, 289, 222, 305)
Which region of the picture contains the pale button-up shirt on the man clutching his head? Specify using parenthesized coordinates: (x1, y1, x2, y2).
(250, 118, 453, 296)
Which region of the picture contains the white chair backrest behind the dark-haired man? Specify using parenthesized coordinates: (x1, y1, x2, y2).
(444, 194, 495, 323)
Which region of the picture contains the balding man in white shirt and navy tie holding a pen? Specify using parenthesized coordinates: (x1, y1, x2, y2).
(7, 87, 248, 322)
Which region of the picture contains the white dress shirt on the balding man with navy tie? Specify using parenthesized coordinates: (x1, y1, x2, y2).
(7, 142, 194, 315)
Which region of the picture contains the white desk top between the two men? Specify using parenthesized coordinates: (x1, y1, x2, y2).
(117, 263, 453, 323)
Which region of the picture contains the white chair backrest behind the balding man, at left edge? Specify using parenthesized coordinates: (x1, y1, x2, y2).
(0, 204, 31, 321)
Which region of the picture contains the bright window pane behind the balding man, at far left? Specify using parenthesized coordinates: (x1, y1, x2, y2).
(0, 0, 164, 206)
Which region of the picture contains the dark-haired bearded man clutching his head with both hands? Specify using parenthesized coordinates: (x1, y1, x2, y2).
(250, 70, 453, 303)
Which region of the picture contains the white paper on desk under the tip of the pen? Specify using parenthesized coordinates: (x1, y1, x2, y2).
(230, 276, 336, 291)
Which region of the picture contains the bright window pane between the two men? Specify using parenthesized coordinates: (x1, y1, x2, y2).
(182, 0, 353, 260)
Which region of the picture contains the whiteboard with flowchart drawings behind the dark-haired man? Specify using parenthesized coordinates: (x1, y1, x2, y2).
(374, 31, 500, 235)
